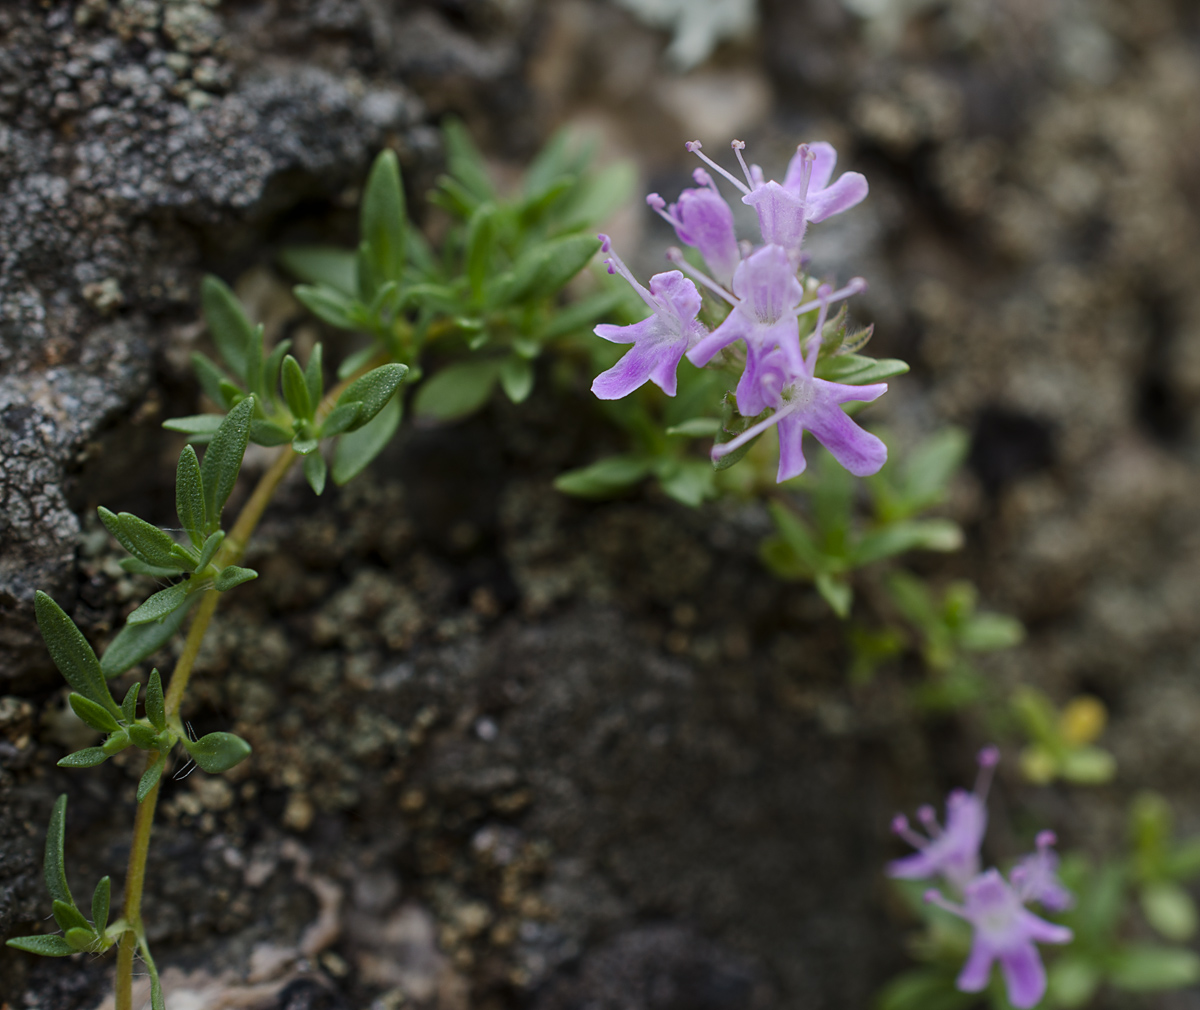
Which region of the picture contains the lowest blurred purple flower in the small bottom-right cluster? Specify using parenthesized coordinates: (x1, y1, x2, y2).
(925, 870, 1073, 1010)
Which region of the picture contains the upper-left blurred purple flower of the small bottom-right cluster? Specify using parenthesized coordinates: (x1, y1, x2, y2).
(888, 747, 1000, 891)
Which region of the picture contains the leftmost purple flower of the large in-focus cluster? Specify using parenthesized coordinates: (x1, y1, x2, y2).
(592, 235, 706, 399)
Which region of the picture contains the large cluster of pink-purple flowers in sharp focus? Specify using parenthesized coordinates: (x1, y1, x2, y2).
(592, 140, 888, 481)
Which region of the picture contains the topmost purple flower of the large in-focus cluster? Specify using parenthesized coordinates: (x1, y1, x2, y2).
(688, 140, 868, 263)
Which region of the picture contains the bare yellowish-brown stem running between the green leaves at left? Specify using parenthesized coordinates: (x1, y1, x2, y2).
(115, 355, 382, 1010)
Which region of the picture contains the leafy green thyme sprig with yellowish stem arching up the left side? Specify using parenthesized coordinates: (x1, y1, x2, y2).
(7, 122, 628, 1010)
